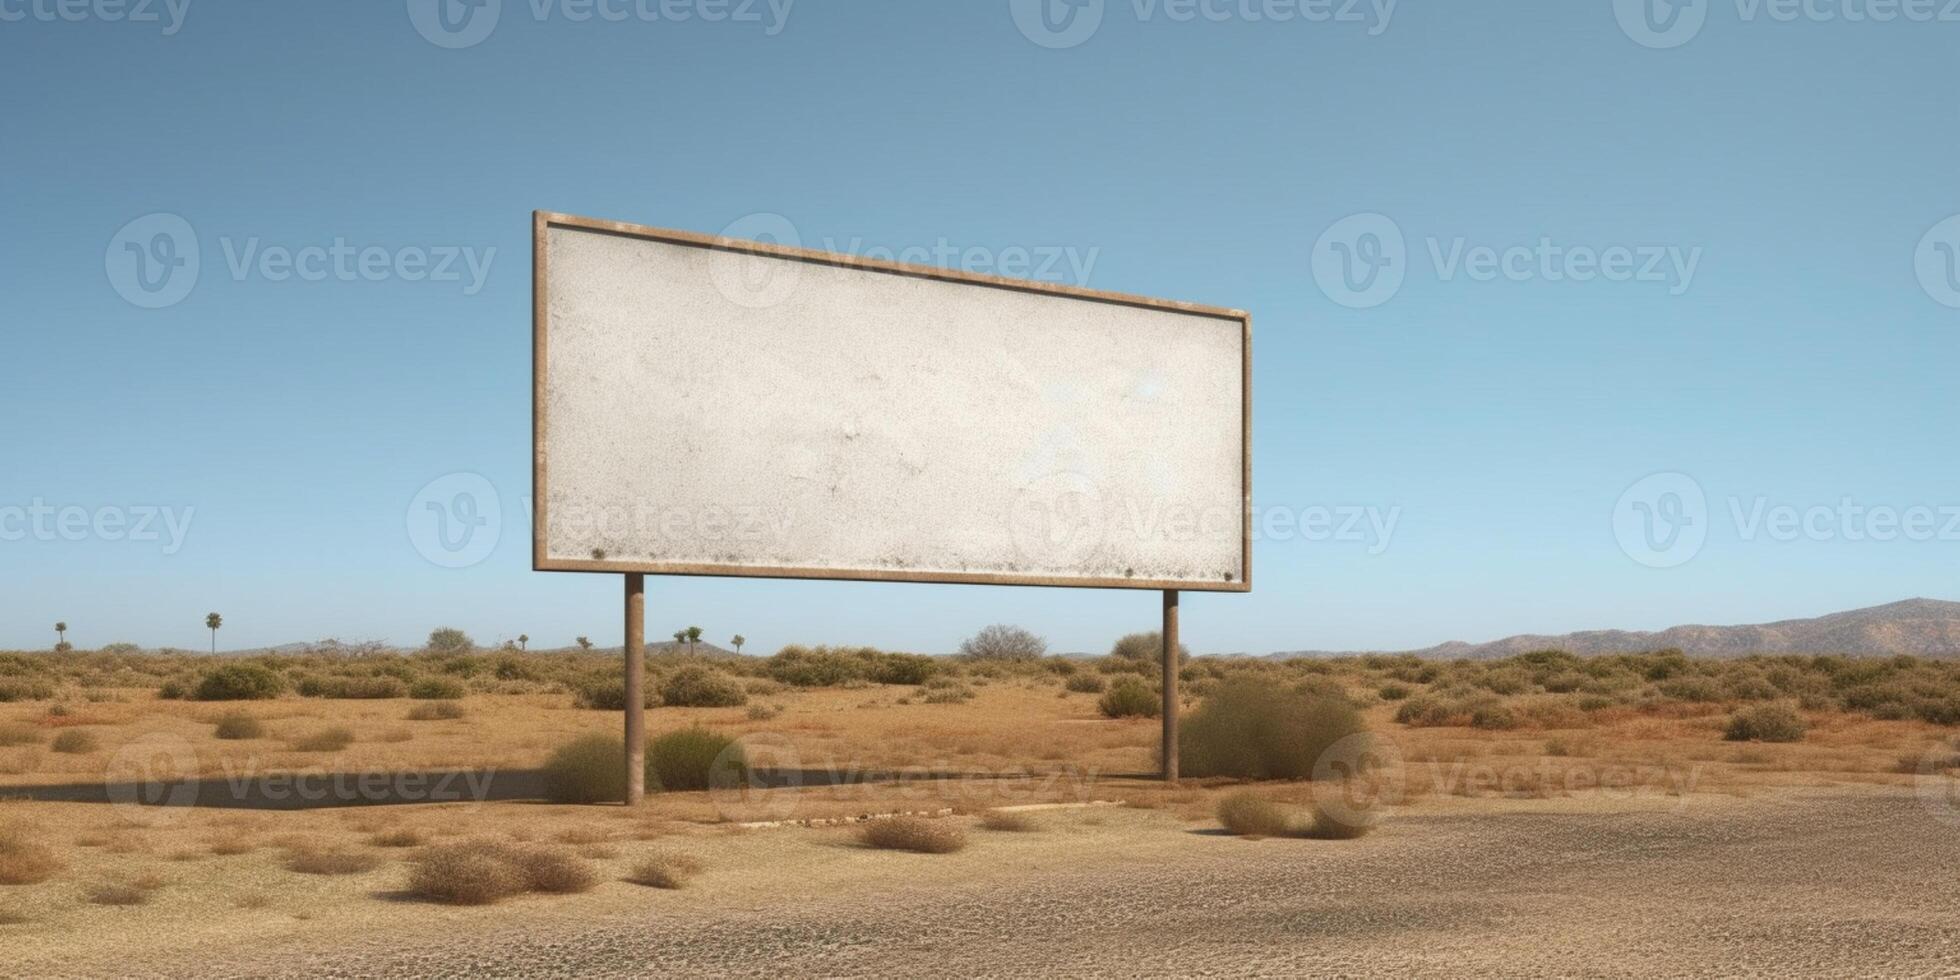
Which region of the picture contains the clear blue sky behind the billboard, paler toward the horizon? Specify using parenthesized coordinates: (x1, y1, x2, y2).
(0, 0, 1960, 653)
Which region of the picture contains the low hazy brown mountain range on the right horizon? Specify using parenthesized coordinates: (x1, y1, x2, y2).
(1274, 600, 1960, 659)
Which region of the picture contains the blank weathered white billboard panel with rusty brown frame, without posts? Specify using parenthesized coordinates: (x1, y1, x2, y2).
(533, 214, 1250, 592)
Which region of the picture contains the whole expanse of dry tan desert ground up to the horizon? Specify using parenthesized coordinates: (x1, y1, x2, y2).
(0, 655, 1960, 976)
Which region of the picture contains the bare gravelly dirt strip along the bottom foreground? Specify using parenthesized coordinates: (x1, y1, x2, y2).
(4, 786, 1960, 976)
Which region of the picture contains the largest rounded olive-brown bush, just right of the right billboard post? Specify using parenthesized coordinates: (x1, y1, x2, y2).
(1178, 678, 1366, 780)
